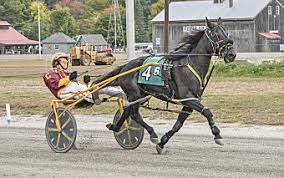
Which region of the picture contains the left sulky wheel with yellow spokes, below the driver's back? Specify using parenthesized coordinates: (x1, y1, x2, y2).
(45, 108, 77, 153)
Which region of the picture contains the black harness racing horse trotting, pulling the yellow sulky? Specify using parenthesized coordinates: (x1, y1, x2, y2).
(93, 18, 236, 154)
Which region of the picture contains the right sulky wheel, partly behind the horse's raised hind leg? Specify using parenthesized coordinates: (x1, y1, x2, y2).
(113, 111, 144, 150)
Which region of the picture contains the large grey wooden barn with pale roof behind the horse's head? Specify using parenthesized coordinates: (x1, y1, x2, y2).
(152, 0, 284, 52)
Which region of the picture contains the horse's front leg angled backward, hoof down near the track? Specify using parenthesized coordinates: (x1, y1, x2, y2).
(156, 106, 193, 154)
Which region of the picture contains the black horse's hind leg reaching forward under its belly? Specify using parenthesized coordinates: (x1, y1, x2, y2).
(131, 105, 158, 144)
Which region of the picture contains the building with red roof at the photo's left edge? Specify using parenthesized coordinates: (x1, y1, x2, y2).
(0, 21, 38, 54)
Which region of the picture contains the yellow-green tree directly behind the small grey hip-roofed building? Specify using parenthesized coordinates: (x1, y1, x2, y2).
(50, 5, 79, 36)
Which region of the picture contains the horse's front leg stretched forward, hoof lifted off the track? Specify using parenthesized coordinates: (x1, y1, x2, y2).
(184, 101, 223, 145)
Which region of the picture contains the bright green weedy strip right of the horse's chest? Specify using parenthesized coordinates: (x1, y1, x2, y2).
(214, 62, 284, 78)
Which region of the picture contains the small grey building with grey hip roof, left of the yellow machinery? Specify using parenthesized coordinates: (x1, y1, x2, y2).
(42, 33, 76, 54)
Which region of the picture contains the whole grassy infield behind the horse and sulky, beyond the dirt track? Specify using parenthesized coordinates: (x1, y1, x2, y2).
(0, 61, 284, 125)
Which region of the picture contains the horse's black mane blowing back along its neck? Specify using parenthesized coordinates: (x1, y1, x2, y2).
(170, 30, 205, 60)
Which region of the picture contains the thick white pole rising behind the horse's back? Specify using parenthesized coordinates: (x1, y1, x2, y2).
(126, 0, 135, 60)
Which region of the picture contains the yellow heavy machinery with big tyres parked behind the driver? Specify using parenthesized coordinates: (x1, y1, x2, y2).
(70, 44, 116, 66)
